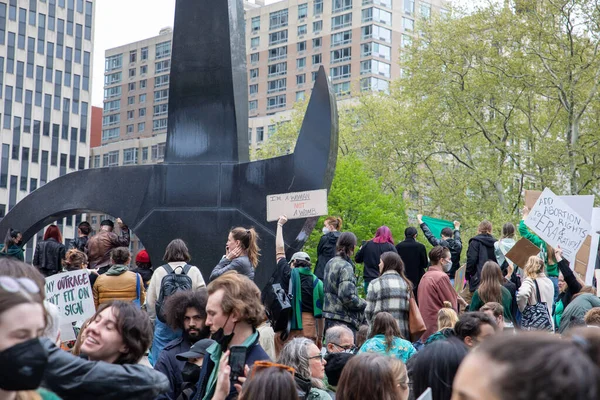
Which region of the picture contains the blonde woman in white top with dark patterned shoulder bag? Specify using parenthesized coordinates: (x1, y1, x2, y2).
(517, 256, 554, 330)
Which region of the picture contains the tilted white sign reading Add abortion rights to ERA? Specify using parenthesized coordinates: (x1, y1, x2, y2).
(525, 188, 592, 263)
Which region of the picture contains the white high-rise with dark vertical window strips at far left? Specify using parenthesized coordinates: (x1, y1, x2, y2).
(0, 0, 95, 260)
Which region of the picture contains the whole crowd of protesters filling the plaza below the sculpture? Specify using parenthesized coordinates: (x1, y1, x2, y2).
(0, 208, 600, 400)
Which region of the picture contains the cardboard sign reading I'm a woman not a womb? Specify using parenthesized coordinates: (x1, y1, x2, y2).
(267, 189, 327, 221)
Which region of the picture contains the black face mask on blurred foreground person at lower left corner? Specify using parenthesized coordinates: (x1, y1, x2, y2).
(0, 338, 48, 391)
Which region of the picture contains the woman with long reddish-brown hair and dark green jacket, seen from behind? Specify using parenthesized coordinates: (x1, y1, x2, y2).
(469, 261, 514, 323)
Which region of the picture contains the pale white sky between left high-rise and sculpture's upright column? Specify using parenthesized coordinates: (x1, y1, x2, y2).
(92, 0, 281, 107)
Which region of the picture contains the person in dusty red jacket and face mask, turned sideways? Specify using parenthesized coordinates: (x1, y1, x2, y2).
(417, 246, 466, 342)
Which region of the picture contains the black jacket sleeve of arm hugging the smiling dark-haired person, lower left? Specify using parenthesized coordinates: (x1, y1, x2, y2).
(40, 338, 169, 400)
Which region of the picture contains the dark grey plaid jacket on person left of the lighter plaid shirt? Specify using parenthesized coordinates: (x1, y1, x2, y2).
(323, 257, 367, 329)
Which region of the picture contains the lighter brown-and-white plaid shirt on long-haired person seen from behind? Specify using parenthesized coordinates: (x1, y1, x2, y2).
(365, 271, 410, 339)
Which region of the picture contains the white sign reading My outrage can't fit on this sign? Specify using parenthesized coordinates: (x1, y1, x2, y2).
(46, 269, 96, 341)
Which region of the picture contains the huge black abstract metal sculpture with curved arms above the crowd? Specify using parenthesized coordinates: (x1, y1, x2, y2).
(0, 0, 338, 287)
